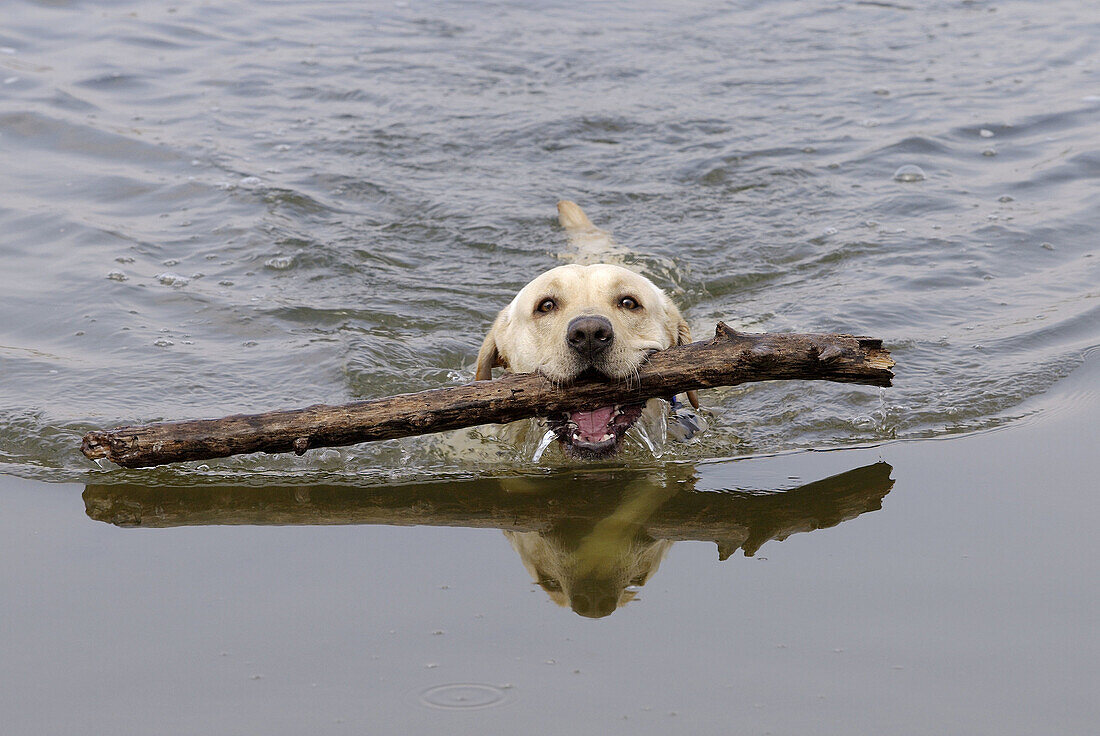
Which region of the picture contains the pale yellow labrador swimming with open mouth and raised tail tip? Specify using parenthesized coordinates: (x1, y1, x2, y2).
(476, 201, 699, 459)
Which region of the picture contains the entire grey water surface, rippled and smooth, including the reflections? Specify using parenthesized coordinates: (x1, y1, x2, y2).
(0, 0, 1100, 735)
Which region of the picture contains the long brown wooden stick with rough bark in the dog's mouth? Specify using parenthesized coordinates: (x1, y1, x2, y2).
(80, 322, 894, 468)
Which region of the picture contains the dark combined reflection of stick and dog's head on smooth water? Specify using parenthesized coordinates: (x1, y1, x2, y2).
(84, 462, 893, 618)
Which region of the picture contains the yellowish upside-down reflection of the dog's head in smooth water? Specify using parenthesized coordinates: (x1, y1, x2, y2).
(504, 482, 678, 618)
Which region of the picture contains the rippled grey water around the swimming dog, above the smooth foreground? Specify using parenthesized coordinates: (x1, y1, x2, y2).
(0, 2, 1100, 480)
